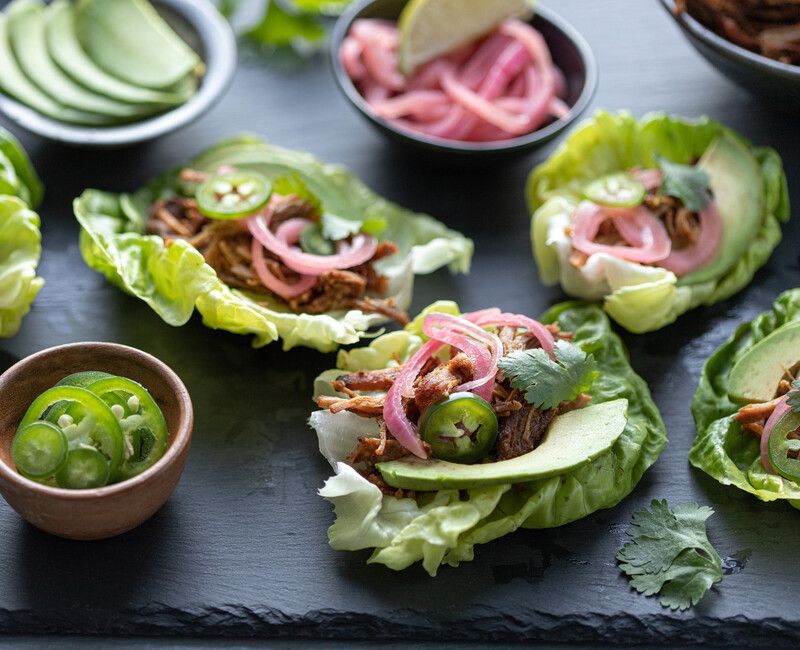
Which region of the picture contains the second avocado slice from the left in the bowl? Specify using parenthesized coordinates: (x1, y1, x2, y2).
(6, 0, 146, 122)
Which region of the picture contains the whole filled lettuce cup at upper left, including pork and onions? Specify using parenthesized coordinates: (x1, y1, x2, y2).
(74, 136, 473, 352)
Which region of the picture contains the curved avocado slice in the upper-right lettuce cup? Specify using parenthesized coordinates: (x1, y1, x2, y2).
(678, 133, 766, 285)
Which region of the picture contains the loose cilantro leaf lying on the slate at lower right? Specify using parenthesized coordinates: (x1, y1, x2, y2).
(617, 499, 722, 610)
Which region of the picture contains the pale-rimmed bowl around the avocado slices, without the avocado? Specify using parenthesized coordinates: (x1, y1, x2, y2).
(0, 0, 238, 147)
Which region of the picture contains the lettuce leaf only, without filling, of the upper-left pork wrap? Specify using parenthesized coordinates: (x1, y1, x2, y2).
(74, 136, 473, 352)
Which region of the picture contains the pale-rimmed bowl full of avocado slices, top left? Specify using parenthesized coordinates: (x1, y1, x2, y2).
(0, 0, 236, 147)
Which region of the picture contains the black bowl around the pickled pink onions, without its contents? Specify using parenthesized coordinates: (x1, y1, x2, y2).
(331, 0, 597, 159)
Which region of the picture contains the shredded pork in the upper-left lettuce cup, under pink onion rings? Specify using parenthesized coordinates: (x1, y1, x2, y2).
(147, 184, 408, 325)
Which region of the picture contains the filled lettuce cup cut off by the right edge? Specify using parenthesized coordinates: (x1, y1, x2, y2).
(689, 289, 800, 507)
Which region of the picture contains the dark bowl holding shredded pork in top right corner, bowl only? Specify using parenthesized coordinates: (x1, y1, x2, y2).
(661, 0, 800, 105)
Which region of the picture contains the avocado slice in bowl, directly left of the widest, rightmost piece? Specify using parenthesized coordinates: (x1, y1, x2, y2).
(44, 0, 191, 107)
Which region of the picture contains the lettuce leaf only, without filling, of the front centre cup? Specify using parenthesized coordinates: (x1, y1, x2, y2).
(310, 302, 667, 575)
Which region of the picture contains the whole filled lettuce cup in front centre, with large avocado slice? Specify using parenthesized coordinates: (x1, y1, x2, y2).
(309, 302, 667, 575)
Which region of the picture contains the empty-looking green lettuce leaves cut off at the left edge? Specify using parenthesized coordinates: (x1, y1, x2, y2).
(0, 128, 44, 337)
